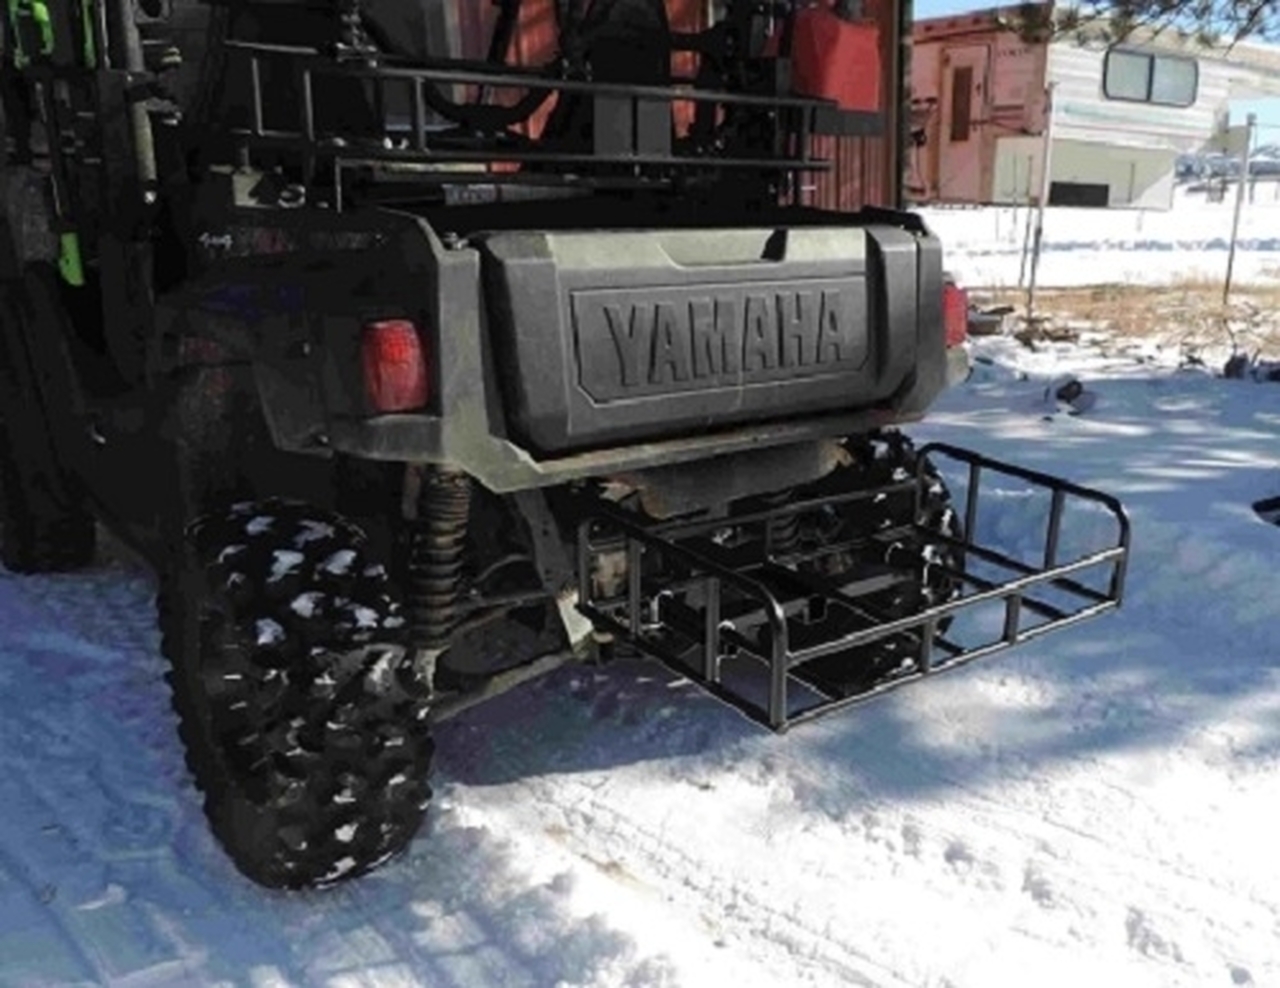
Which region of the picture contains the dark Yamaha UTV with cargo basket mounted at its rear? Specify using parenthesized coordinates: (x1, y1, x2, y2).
(0, 0, 1128, 888)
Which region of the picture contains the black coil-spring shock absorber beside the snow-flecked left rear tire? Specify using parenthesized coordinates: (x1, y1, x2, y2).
(407, 467, 471, 654)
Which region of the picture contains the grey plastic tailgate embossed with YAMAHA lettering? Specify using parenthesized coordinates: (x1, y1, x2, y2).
(472, 225, 942, 453)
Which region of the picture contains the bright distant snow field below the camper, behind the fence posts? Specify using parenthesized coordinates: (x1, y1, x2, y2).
(920, 182, 1280, 288)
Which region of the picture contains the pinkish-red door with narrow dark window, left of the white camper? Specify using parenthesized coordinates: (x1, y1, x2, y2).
(938, 45, 989, 202)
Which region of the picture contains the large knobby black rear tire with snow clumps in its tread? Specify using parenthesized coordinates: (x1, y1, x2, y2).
(160, 499, 433, 888)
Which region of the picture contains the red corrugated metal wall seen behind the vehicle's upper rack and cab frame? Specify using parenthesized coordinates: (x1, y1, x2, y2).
(453, 0, 901, 210)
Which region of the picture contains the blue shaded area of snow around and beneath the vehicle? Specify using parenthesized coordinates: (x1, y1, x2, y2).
(0, 366, 1280, 985)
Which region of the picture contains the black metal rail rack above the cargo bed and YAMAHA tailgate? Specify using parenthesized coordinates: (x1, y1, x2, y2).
(213, 40, 844, 198)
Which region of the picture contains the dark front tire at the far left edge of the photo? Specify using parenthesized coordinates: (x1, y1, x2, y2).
(0, 270, 95, 573)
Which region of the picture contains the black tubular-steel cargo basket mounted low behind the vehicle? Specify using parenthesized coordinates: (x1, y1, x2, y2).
(577, 443, 1130, 732)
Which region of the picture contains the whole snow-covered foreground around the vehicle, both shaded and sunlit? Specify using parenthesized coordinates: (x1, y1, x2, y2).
(0, 235, 1280, 988)
